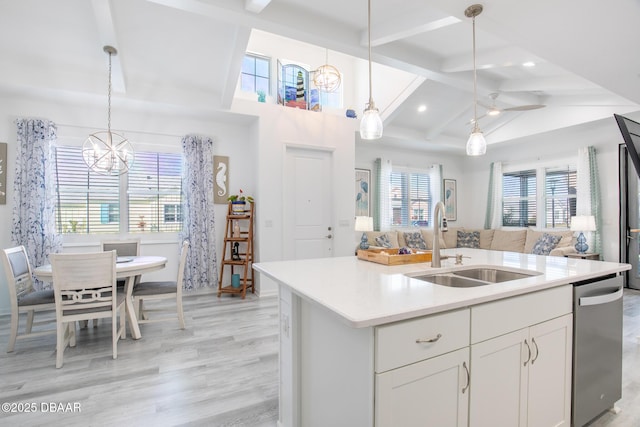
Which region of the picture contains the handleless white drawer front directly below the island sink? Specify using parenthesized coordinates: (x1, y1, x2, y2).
(471, 285, 573, 344)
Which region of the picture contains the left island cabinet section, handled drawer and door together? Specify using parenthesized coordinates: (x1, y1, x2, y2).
(375, 309, 470, 427)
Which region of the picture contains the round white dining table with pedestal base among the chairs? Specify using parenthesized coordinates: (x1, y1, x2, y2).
(33, 256, 167, 340)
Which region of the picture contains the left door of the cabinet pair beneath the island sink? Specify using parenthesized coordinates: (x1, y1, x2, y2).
(469, 328, 530, 427)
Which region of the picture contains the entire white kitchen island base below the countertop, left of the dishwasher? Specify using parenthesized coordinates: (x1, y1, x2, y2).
(280, 285, 573, 427)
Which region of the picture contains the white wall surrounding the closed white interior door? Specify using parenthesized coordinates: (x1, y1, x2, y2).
(233, 100, 359, 294)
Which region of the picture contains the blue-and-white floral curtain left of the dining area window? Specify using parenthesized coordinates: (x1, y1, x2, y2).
(11, 119, 62, 288)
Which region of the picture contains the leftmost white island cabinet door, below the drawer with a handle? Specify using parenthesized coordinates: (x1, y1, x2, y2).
(375, 347, 469, 427)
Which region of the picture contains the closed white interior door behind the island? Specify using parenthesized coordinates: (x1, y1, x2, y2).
(283, 147, 333, 259)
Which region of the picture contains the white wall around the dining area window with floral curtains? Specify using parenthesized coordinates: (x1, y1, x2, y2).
(0, 94, 258, 313)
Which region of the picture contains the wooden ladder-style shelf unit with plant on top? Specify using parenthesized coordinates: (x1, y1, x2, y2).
(218, 202, 255, 299)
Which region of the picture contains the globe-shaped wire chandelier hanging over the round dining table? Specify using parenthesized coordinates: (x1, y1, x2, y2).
(82, 46, 135, 175)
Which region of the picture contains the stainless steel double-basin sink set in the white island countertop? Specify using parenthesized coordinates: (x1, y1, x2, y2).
(407, 267, 542, 288)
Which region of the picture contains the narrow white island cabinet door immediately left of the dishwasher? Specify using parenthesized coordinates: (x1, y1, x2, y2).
(527, 315, 573, 427)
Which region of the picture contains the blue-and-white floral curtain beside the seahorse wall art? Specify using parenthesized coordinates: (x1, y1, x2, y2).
(180, 135, 218, 290)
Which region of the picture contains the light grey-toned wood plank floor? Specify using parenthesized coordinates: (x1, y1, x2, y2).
(0, 290, 640, 427)
